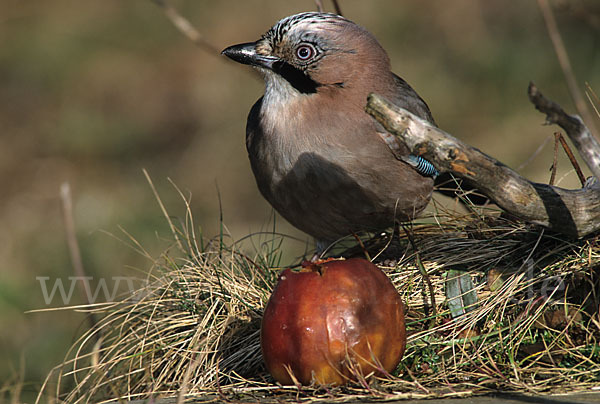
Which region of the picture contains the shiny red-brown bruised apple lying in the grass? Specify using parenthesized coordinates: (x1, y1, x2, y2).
(261, 258, 406, 385)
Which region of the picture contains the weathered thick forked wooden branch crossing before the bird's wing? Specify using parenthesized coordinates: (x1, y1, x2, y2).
(366, 84, 600, 237)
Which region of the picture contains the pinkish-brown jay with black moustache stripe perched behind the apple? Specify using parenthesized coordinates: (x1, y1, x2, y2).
(222, 12, 438, 254)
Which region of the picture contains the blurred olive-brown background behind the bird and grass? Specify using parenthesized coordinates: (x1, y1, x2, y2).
(0, 0, 600, 401)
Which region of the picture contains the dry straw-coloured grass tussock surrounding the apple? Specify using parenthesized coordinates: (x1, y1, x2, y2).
(35, 195, 600, 403)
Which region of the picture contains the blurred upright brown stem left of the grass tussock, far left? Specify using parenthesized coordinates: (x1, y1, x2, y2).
(60, 182, 96, 329)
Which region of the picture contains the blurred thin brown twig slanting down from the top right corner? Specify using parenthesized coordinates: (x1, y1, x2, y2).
(538, 0, 598, 139)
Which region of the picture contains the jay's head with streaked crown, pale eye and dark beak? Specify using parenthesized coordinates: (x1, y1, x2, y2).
(222, 12, 391, 95)
